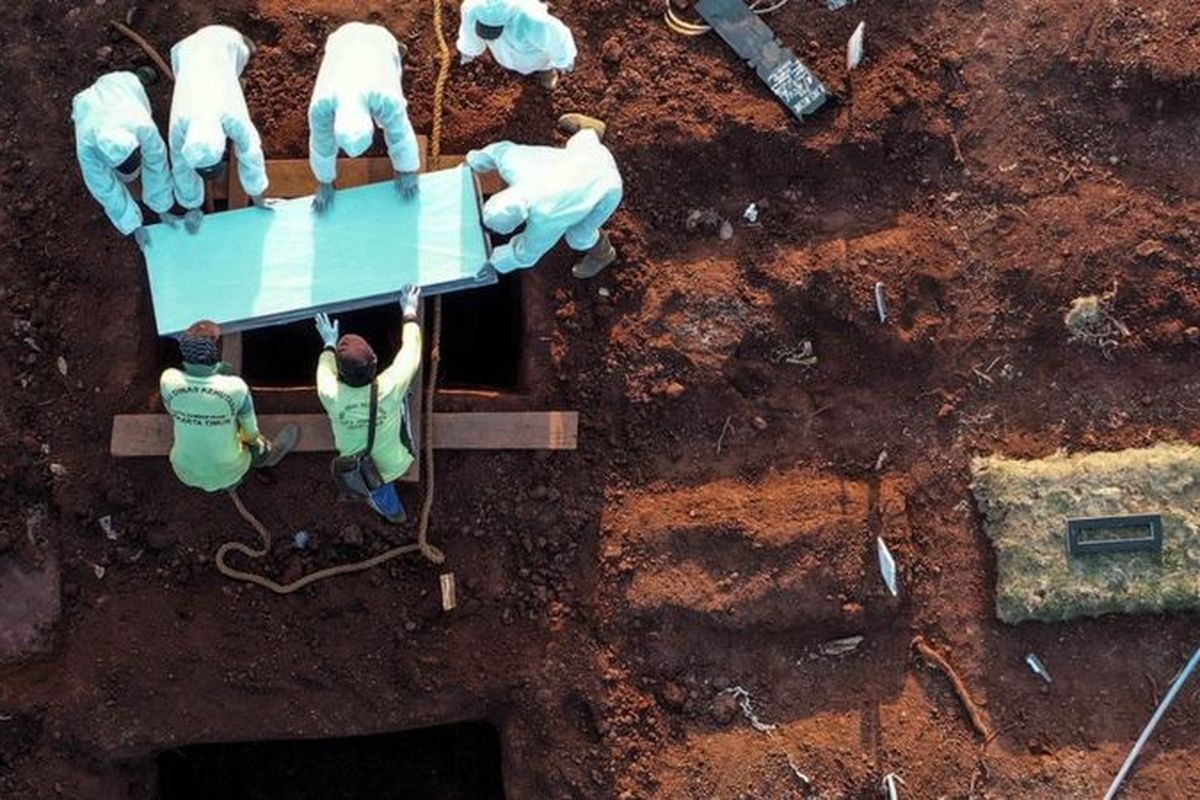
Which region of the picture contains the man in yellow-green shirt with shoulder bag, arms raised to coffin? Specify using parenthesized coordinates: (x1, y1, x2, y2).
(316, 287, 421, 523)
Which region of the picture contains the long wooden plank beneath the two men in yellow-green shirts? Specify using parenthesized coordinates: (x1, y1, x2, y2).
(109, 411, 580, 458)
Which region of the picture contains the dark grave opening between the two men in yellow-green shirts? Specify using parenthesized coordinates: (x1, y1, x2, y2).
(241, 302, 403, 386)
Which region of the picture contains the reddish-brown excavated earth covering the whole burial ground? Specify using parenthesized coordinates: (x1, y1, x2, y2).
(0, 0, 1200, 800)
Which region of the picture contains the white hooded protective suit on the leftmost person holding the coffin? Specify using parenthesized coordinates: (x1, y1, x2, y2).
(71, 72, 175, 234)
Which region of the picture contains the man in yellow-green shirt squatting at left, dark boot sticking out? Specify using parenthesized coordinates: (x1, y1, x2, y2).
(158, 320, 300, 492)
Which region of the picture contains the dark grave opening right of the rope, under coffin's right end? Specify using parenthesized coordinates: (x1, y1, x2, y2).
(438, 271, 524, 391)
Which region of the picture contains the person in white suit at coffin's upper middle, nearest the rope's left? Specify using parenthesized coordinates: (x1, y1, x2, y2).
(308, 23, 421, 212)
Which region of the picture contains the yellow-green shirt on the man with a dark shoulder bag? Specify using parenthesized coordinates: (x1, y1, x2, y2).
(317, 323, 421, 481)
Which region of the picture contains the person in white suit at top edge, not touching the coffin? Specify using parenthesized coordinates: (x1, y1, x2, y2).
(458, 0, 577, 89)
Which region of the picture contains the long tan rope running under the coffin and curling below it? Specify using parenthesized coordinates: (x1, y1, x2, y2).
(216, 0, 451, 595)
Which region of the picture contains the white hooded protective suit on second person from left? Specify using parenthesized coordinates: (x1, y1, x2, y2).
(169, 25, 266, 209)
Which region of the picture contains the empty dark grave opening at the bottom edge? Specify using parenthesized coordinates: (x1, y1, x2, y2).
(156, 722, 504, 800)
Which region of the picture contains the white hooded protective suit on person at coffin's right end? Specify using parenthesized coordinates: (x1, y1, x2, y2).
(467, 130, 624, 272)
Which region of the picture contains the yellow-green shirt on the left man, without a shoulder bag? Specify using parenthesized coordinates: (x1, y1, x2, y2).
(158, 363, 258, 492)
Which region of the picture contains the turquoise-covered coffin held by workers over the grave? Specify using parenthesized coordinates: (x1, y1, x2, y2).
(144, 167, 496, 336)
